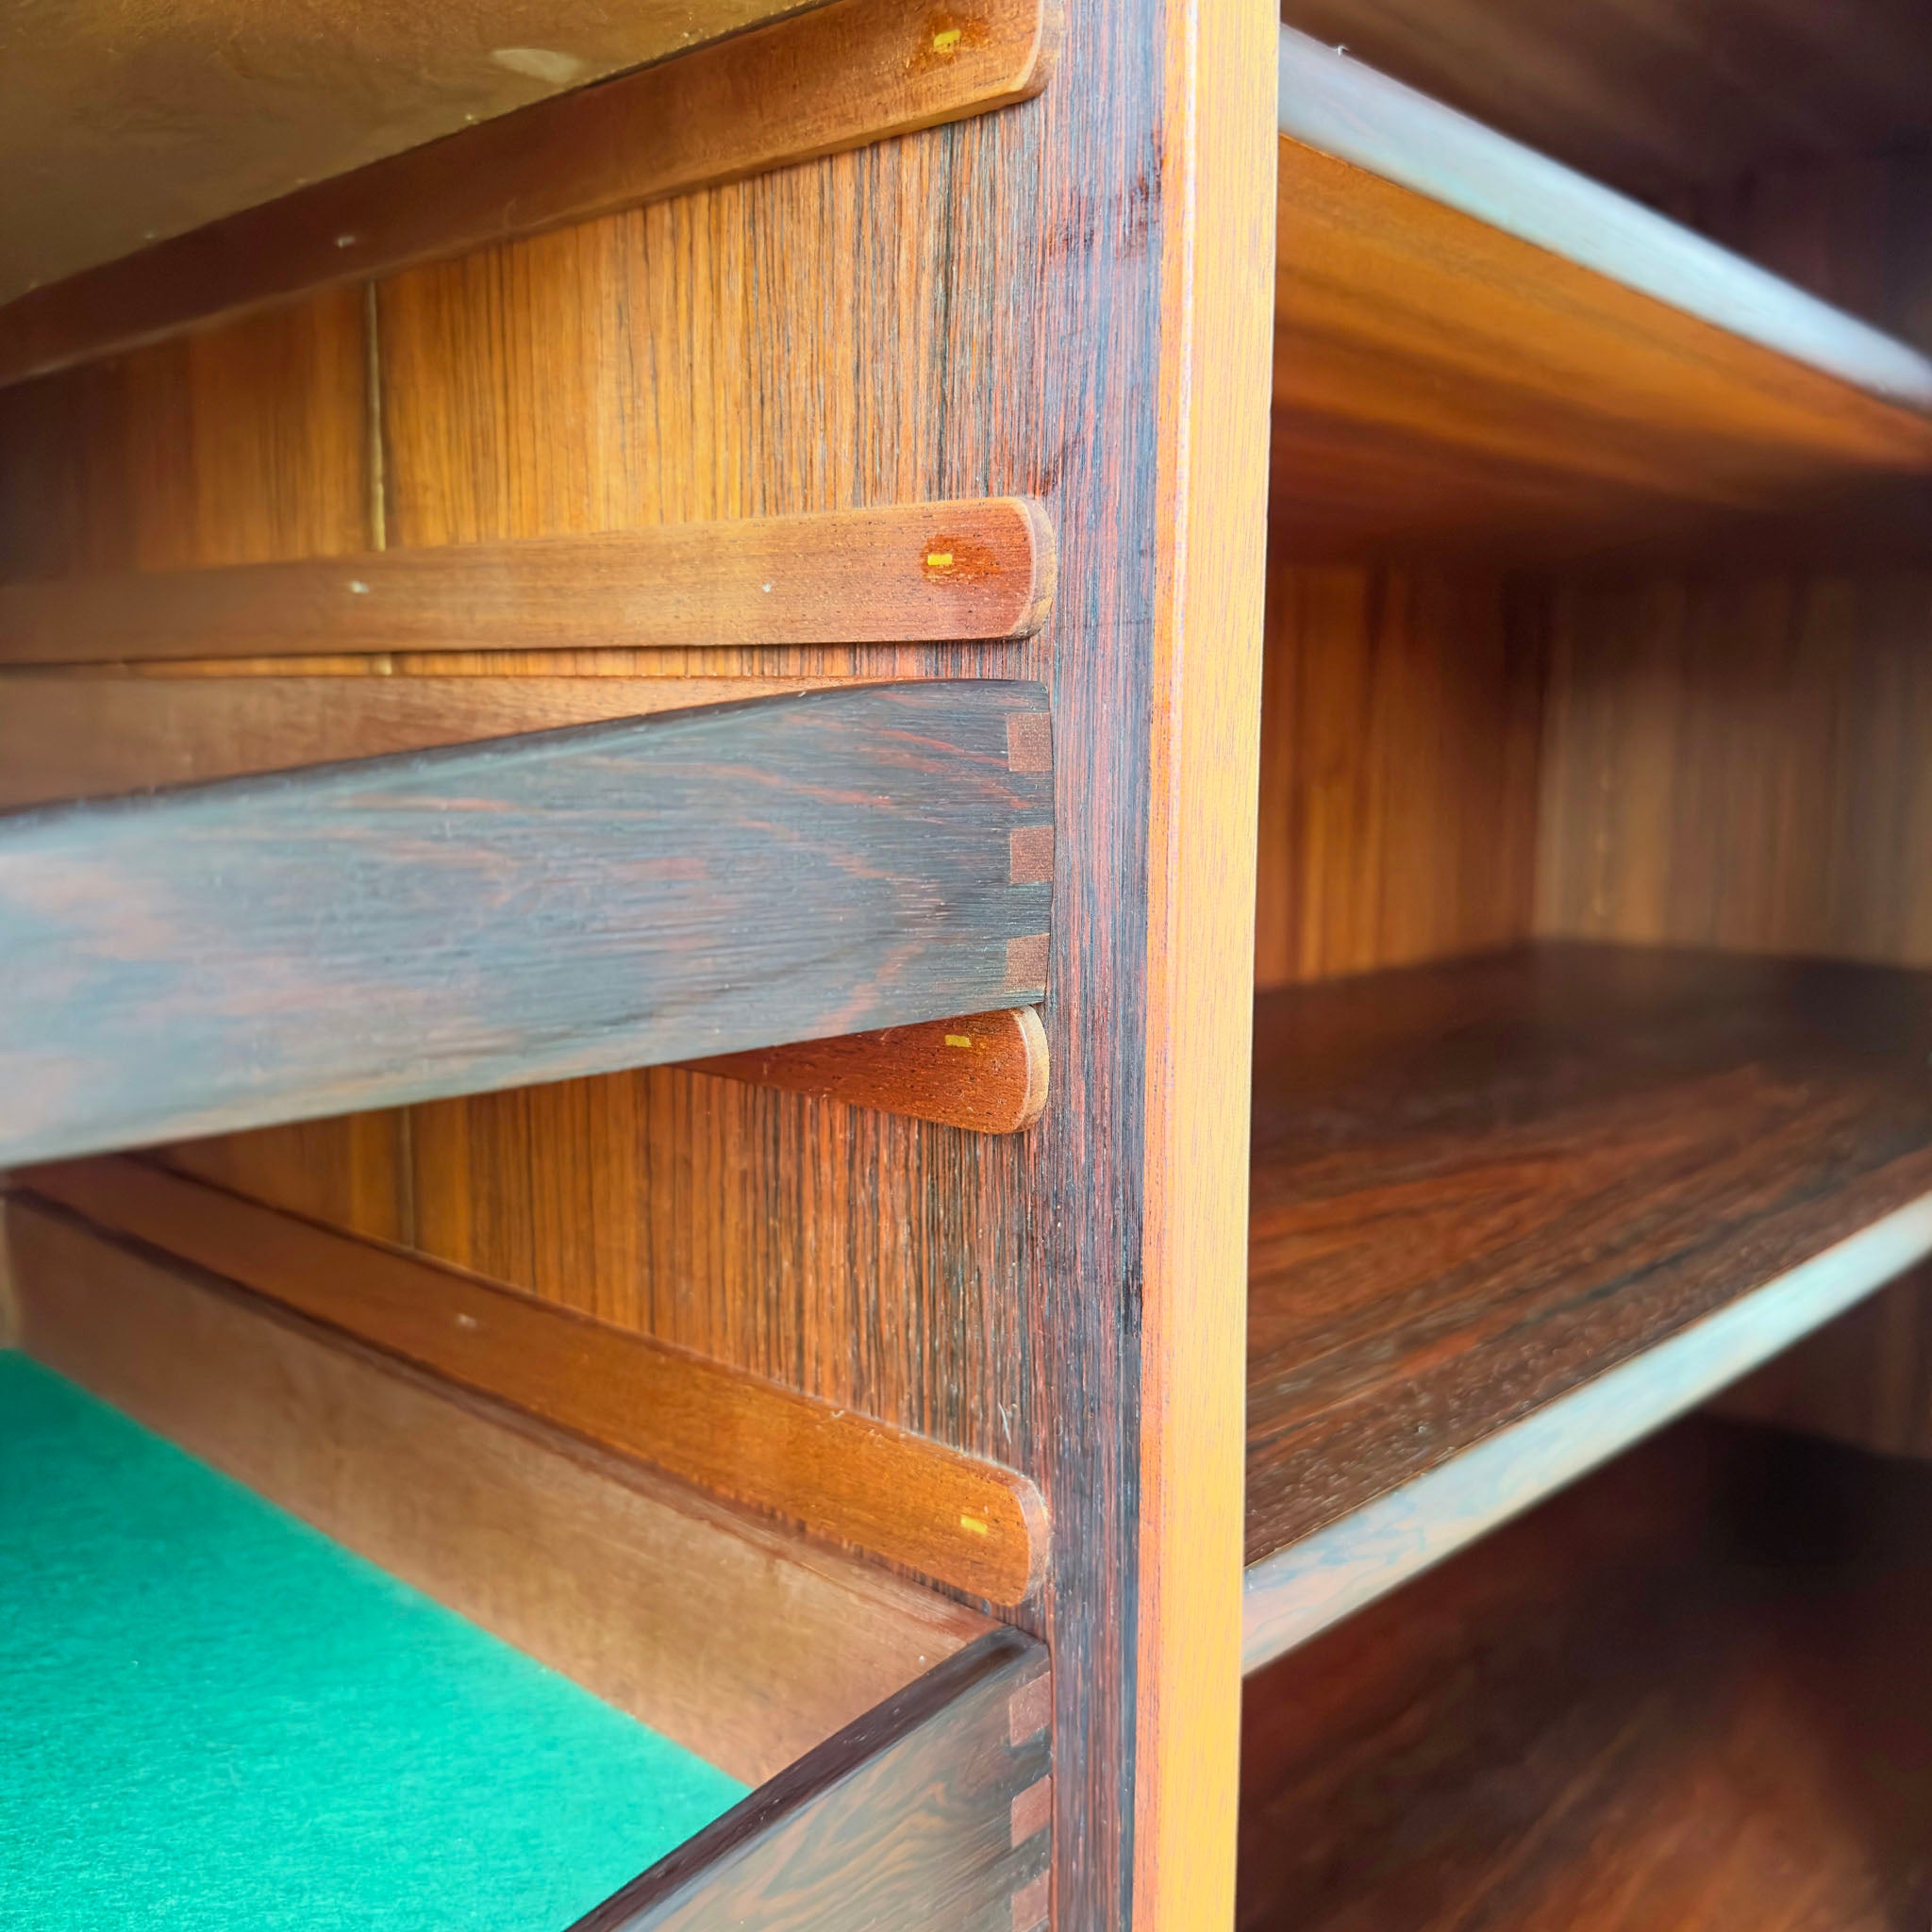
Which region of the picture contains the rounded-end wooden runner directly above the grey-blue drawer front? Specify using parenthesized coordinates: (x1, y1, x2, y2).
(0, 496, 1053, 665)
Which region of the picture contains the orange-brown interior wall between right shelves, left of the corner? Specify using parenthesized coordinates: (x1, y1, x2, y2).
(1254, 555, 1541, 990)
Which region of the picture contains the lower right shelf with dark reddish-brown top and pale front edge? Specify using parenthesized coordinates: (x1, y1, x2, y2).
(1246, 944, 1932, 1669)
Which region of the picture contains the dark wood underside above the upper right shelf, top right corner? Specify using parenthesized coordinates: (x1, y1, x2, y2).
(1281, 0, 1932, 207)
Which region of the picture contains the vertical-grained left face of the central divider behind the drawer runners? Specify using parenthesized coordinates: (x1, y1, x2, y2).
(0, 0, 1265, 1908)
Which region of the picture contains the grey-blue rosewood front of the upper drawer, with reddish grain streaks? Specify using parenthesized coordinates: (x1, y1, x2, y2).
(0, 682, 1051, 1161)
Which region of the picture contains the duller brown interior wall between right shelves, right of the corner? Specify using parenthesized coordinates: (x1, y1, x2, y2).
(1536, 574, 1932, 966)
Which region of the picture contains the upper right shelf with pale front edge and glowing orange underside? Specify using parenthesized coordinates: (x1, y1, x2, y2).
(1274, 29, 1932, 555)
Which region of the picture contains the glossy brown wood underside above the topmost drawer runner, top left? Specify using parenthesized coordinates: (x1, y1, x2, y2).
(0, 0, 809, 301)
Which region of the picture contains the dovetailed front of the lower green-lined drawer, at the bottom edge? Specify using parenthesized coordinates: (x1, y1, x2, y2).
(574, 1631, 1051, 1932)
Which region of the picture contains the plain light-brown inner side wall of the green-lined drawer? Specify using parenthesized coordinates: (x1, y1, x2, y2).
(6, 1194, 985, 1781)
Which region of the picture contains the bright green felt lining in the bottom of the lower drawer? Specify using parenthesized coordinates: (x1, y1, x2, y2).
(0, 1353, 743, 1932)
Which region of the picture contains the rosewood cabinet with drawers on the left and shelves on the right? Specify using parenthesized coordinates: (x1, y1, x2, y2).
(0, 0, 1932, 1932)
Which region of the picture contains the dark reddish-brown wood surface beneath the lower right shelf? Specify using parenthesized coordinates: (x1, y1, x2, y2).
(1239, 1425, 1932, 1932)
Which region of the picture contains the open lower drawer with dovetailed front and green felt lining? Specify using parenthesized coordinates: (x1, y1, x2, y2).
(0, 1194, 1051, 1932)
